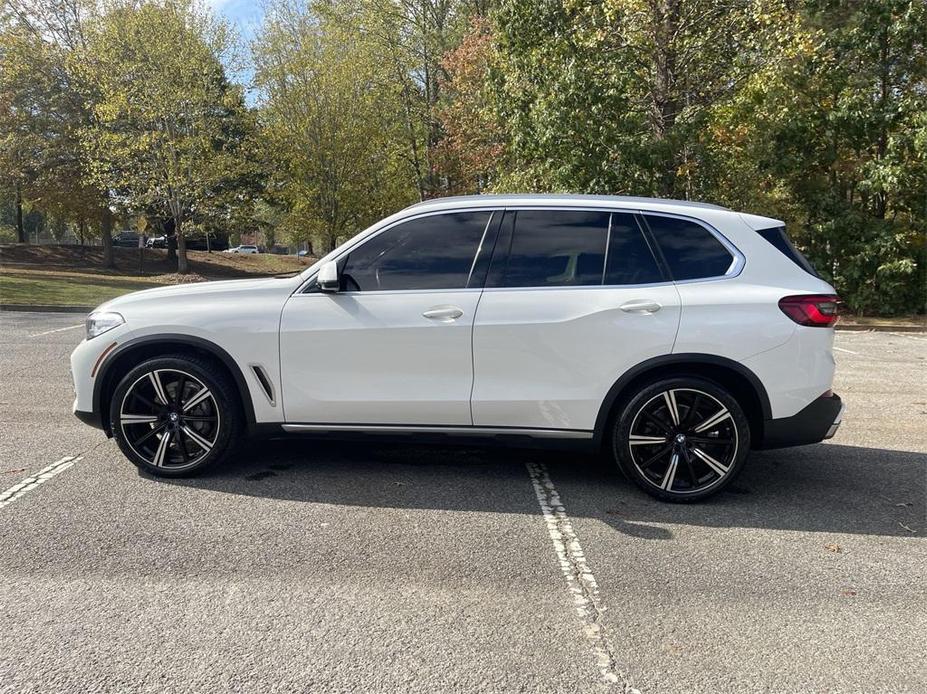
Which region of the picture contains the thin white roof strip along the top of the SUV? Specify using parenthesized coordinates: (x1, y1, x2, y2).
(406, 193, 731, 212)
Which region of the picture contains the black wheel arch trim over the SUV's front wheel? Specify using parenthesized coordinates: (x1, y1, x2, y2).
(93, 333, 256, 435)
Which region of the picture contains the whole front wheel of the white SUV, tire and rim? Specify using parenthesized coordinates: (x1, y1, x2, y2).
(109, 354, 241, 477)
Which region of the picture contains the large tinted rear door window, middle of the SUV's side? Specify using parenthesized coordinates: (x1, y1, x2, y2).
(503, 210, 609, 287)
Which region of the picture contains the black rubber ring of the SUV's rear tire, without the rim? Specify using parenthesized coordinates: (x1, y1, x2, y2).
(611, 376, 750, 503)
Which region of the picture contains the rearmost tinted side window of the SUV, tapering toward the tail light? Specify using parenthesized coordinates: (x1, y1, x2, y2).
(644, 215, 734, 280)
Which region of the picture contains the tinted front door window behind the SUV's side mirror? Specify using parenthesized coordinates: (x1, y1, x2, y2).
(341, 212, 492, 292)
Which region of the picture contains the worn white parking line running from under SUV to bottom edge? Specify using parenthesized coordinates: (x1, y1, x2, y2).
(526, 463, 640, 694)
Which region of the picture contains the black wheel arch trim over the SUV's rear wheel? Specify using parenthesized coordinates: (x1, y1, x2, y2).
(594, 353, 772, 446)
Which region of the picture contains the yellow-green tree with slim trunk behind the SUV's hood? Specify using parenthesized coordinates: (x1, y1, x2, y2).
(73, 0, 252, 273)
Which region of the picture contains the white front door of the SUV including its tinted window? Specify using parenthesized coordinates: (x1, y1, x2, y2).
(280, 211, 492, 426)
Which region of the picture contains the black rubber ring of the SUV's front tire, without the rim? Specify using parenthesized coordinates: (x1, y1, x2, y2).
(109, 356, 239, 477)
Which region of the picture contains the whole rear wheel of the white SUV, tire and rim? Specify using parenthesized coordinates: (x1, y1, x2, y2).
(612, 376, 750, 502)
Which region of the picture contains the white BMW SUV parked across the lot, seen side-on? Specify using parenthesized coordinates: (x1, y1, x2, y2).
(71, 195, 843, 501)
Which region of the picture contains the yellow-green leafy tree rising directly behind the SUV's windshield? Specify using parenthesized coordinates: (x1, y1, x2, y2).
(255, 2, 414, 250)
